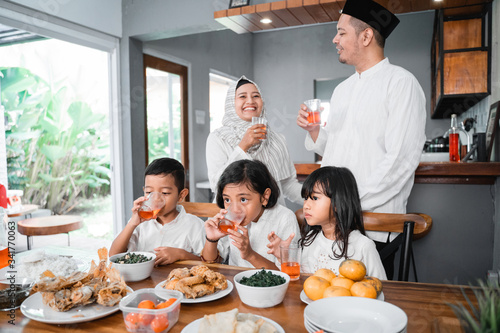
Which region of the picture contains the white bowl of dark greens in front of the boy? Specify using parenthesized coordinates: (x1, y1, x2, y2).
(109, 252, 156, 282)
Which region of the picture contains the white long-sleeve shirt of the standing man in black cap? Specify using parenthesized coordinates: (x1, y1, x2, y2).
(305, 58, 426, 242)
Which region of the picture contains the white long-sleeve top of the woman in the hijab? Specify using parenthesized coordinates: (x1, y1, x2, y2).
(206, 133, 304, 206)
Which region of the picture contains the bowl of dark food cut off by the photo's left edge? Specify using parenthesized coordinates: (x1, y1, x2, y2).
(0, 277, 35, 311)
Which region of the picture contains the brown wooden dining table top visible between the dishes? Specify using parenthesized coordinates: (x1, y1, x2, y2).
(0, 261, 475, 333)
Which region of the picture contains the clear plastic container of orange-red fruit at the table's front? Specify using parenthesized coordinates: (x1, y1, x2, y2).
(120, 288, 184, 333)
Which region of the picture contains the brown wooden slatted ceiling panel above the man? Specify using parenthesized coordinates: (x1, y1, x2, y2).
(214, 0, 493, 34)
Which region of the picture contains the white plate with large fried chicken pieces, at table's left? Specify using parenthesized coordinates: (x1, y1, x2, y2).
(21, 248, 132, 324)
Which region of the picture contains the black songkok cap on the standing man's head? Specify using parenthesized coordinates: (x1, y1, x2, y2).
(342, 0, 399, 38)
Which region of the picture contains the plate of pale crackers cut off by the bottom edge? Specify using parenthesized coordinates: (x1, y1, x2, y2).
(181, 309, 285, 333)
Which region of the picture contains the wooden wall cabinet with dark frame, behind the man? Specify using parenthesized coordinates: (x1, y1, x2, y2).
(431, 3, 492, 119)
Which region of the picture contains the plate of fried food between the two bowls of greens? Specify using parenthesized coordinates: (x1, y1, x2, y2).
(155, 265, 233, 303)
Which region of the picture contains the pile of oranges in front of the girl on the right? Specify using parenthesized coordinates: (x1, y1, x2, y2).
(304, 259, 382, 301)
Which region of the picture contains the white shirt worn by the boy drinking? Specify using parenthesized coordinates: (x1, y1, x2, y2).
(131, 205, 205, 256)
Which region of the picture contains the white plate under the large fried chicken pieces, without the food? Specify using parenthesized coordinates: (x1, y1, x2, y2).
(21, 287, 133, 325)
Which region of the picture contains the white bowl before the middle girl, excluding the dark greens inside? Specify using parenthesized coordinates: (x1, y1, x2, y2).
(234, 269, 290, 308)
